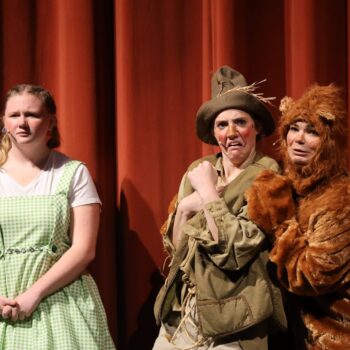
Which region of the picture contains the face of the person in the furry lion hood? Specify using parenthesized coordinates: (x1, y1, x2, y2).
(286, 121, 320, 165)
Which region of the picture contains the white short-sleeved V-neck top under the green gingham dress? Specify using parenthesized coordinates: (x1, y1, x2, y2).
(0, 151, 101, 208)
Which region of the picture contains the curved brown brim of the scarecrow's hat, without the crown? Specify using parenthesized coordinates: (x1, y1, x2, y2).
(196, 91, 275, 145)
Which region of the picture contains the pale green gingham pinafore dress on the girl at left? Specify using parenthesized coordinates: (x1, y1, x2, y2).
(0, 161, 115, 350)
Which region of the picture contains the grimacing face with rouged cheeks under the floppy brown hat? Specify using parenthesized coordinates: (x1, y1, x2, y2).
(214, 109, 258, 166)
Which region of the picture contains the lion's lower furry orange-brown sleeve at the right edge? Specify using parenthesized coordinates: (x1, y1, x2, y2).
(270, 209, 350, 296)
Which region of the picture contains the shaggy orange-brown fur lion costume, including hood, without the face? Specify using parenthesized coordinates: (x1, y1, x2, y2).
(247, 85, 350, 350)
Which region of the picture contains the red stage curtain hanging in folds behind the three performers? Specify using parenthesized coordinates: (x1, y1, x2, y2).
(0, 0, 350, 350)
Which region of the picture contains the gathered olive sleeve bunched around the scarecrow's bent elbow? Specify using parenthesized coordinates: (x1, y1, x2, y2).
(182, 198, 266, 270)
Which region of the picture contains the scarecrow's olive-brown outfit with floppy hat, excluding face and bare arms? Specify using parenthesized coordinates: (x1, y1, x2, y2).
(154, 66, 286, 350)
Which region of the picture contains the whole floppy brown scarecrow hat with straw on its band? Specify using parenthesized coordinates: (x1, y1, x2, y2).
(196, 66, 275, 145)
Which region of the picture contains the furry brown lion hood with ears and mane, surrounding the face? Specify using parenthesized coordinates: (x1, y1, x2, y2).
(278, 84, 347, 195)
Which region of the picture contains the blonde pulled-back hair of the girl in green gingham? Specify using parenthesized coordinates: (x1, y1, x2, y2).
(0, 84, 61, 166)
